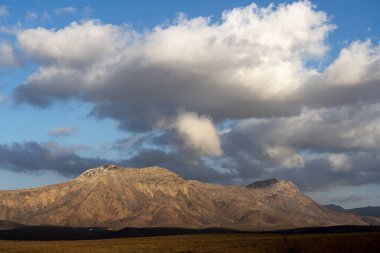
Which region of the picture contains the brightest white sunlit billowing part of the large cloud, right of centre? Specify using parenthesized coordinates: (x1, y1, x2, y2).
(145, 2, 334, 99)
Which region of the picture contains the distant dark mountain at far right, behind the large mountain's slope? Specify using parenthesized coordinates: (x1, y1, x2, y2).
(325, 204, 380, 226)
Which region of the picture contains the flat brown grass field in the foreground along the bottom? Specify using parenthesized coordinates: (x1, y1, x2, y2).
(0, 233, 380, 253)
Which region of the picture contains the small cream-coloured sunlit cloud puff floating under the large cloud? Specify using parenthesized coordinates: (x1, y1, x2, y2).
(174, 112, 222, 156)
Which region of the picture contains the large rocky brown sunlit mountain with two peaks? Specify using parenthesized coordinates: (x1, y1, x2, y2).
(0, 165, 366, 230)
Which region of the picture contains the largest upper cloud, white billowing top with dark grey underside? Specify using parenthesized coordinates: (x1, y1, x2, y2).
(16, 1, 334, 125)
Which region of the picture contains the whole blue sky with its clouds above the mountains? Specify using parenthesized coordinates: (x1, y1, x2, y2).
(0, 0, 380, 208)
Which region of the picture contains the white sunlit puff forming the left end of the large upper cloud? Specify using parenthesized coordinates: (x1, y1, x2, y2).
(17, 20, 129, 68)
